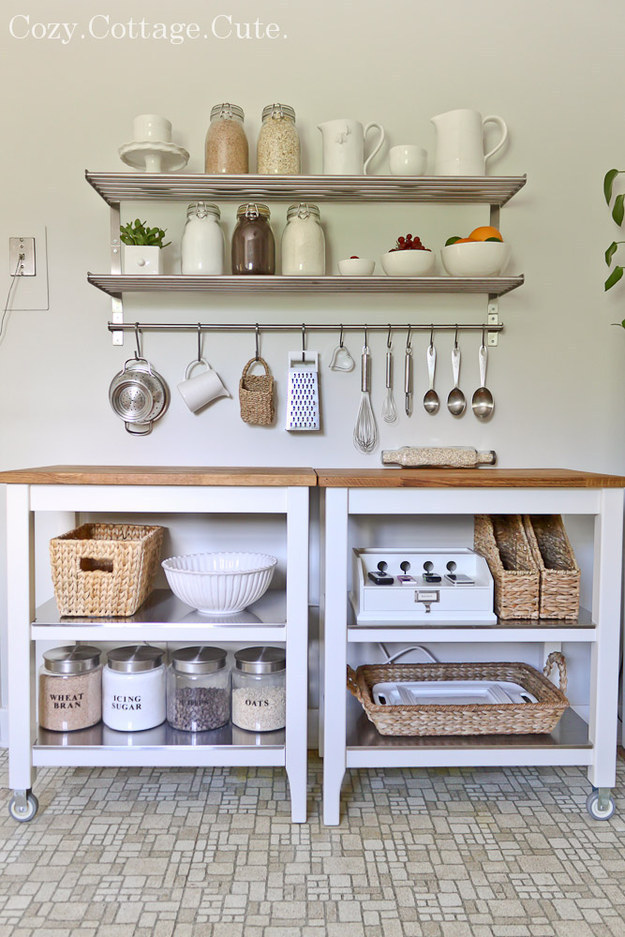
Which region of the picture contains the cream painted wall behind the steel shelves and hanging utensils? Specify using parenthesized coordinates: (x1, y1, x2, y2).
(0, 0, 625, 724)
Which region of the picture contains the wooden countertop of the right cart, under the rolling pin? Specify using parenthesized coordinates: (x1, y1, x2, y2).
(315, 468, 625, 488)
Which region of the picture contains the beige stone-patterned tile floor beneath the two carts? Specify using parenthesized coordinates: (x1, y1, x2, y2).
(0, 752, 625, 937)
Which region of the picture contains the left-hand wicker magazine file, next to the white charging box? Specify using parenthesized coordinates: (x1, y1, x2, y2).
(474, 514, 540, 619)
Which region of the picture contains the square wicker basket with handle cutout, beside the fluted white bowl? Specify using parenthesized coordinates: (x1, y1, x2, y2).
(50, 524, 164, 618)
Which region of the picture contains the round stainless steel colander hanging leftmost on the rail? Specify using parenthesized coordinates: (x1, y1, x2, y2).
(109, 357, 169, 436)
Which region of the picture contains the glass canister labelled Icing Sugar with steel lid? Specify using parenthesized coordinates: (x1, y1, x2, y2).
(102, 644, 166, 732)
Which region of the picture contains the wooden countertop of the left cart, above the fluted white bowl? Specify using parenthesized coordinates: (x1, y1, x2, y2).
(0, 465, 317, 488)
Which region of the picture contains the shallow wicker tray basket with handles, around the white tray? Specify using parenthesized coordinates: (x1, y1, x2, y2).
(347, 651, 569, 736)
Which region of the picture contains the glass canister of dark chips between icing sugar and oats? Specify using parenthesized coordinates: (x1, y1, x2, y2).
(167, 647, 230, 732)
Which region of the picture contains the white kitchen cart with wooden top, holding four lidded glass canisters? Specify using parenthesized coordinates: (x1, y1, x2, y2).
(0, 466, 316, 823)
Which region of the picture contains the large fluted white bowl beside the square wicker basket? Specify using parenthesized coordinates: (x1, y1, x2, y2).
(161, 553, 278, 615)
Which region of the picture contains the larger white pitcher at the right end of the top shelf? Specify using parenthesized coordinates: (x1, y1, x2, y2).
(432, 108, 508, 176)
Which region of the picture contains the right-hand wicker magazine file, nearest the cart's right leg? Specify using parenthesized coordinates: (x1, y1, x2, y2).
(523, 514, 580, 619)
